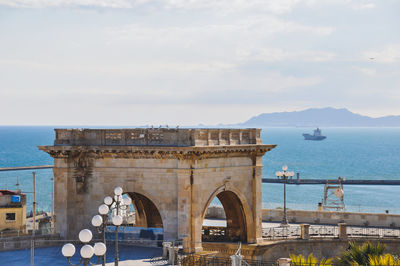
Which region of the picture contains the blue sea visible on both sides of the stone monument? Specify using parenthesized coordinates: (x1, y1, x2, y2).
(0, 126, 400, 214)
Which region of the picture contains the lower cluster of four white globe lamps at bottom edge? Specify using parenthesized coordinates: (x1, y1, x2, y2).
(61, 229, 107, 266)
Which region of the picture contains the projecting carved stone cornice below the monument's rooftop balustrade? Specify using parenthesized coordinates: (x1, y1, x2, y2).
(39, 144, 276, 160)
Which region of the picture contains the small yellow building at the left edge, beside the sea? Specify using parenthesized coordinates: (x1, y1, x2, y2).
(0, 190, 26, 232)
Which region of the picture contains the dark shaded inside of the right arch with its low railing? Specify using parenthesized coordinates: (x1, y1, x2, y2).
(202, 187, 248, 243)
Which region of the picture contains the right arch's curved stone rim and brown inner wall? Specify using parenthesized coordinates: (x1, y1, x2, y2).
(201, 185, 252, 243)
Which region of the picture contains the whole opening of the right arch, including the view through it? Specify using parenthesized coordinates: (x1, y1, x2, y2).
(202, 191, 247, 243)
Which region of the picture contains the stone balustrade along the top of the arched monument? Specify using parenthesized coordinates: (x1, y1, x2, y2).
(54, 128, 262, 147)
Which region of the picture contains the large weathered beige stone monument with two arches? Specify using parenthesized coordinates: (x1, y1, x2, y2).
(39, 128, 275, 252)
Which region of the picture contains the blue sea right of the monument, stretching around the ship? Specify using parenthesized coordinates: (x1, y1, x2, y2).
(262, 128, 400, 213)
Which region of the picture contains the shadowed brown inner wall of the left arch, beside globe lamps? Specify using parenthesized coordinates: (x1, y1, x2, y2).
(125, 192, 163, 228)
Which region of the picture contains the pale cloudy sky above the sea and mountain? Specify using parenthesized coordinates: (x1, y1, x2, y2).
(0, 0, 400, 126)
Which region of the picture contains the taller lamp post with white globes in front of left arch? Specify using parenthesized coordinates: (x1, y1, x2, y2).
(92, 187, 132, 266)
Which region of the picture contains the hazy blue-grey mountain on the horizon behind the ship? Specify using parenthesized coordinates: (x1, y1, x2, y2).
(239, 107, 400, 127)
